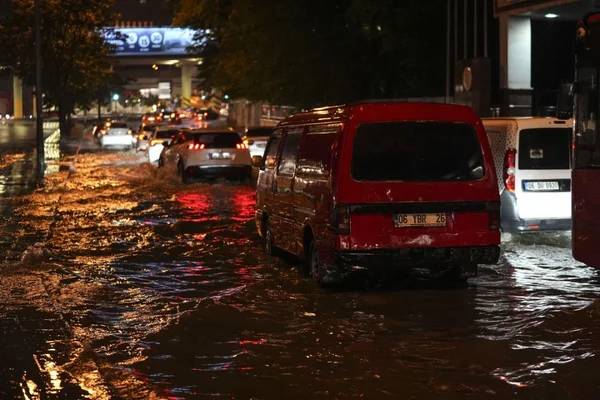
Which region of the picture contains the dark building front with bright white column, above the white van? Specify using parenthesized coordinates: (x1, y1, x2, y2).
(447, 0, 600, 116)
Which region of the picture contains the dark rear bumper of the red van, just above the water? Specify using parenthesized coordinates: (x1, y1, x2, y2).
(335, 246, 500, 273)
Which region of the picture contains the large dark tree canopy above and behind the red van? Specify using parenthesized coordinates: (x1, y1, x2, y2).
(175, 0, 445, 106)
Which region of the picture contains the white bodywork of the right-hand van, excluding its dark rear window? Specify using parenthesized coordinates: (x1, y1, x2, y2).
(483, 117, 573, 232)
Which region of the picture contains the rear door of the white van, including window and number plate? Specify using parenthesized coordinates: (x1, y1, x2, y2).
(515, 128, 572, 220)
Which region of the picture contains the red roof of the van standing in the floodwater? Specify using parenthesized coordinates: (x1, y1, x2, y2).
(279, 99, 477, 126)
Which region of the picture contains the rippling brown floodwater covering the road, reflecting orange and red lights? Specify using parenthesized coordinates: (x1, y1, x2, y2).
(0, 148, 600, 399)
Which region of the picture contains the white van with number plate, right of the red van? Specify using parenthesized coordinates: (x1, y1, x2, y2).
(483, 117, 573, 233)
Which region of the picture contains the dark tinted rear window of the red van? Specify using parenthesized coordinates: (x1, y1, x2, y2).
(352, 122, 484, 181)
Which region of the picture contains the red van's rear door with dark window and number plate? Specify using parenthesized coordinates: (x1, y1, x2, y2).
(340, 121, 498, 250)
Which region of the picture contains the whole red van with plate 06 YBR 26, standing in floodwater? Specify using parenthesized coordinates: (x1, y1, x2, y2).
(256, 101, 500, 285)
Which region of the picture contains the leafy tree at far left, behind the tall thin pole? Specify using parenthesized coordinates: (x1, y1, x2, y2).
(0, 0, 114, 135)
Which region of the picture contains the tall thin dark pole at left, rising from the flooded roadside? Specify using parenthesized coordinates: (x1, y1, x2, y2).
(33, 0, 46, 186)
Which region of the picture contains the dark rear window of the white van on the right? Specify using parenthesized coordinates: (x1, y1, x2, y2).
(517, 128, 572, 169)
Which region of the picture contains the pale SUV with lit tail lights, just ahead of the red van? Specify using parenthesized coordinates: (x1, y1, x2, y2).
(159, 129, 252, 183)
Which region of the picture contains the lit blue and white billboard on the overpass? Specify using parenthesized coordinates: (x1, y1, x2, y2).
(105, 27, 205, 56)
